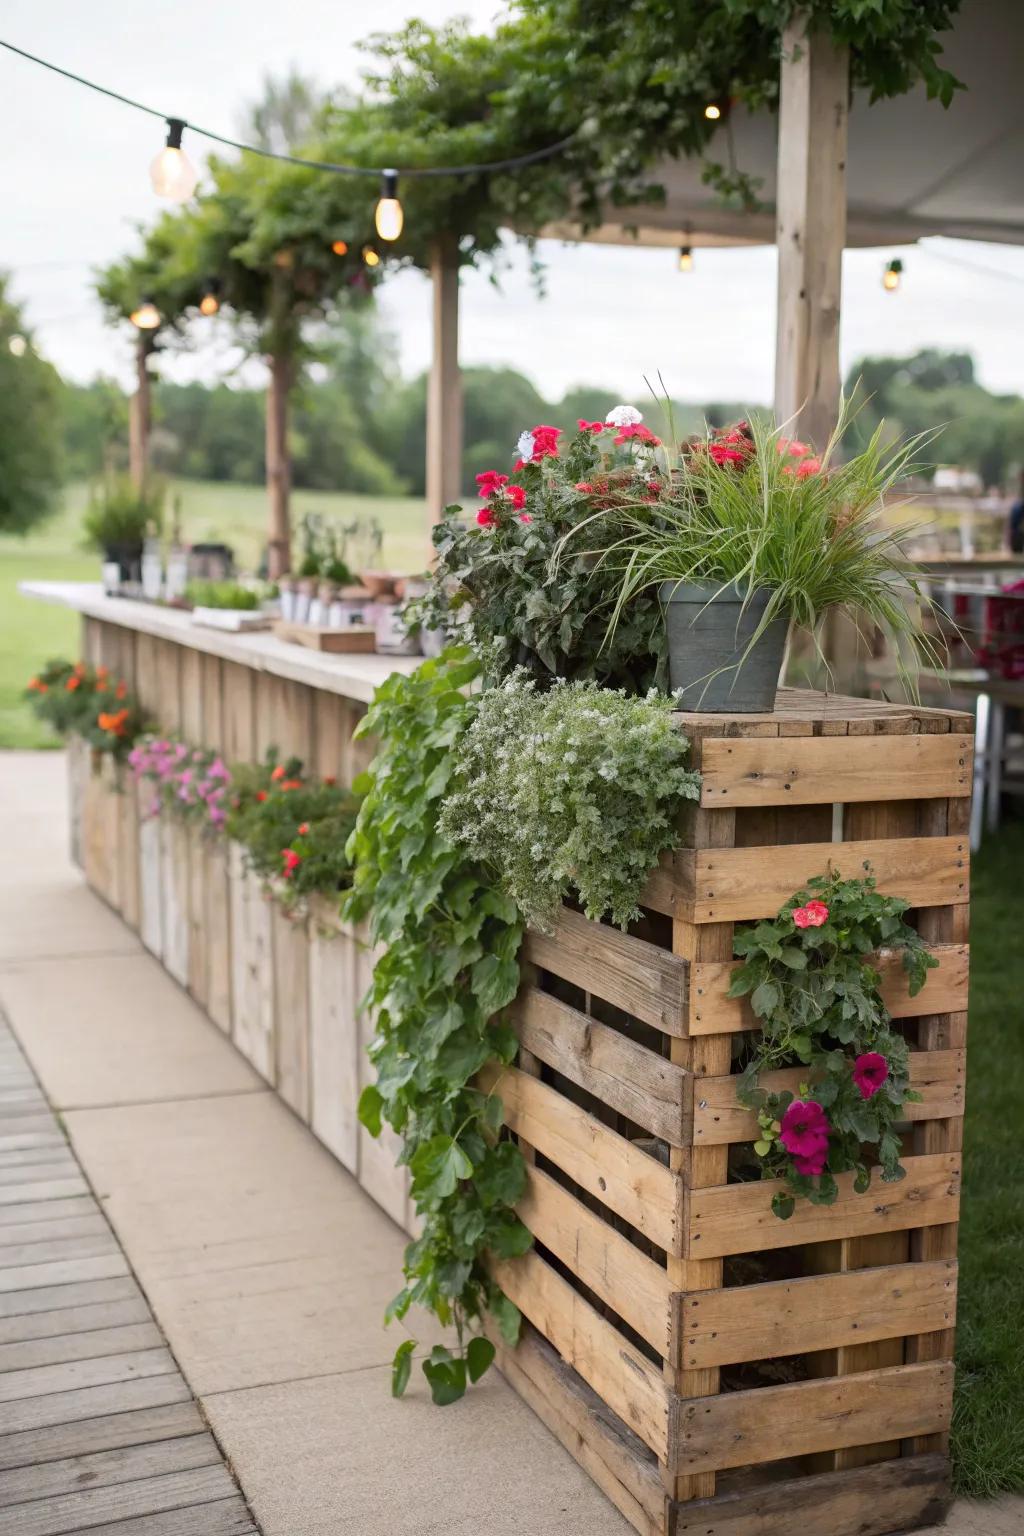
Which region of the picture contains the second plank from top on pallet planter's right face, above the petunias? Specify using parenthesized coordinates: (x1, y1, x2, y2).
(676, 837, 969, 923)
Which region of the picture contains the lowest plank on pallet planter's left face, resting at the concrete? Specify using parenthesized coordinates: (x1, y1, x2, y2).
(488, 1322, 665, 1536)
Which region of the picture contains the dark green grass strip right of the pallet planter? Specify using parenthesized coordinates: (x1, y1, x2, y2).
(953, 822, 1024, 1498)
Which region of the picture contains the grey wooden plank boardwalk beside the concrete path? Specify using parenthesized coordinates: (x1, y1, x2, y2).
(0, 1015, 258, 1536)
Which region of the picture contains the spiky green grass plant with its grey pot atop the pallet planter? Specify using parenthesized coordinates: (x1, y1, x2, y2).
(580, 419, 927, 713)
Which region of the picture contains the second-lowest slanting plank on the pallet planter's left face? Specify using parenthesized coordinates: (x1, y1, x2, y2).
(491, 1253, 671, 1461)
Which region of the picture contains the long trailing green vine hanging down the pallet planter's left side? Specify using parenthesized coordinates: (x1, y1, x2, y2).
(342, 648, 531, 1404)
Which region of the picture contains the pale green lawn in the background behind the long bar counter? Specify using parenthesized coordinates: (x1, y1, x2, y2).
(0, 481, 430, 750)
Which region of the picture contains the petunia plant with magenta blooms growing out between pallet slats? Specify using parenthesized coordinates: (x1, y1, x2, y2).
(729, 872, 936, 1220)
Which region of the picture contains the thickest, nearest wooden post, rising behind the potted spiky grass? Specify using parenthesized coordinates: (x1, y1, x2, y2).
(775, 12, 849, 449)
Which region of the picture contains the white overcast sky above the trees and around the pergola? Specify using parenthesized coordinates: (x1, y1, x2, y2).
(0, 0, 1024, 401)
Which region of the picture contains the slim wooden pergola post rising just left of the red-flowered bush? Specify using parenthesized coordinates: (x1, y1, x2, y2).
(427, 235, 462, 522)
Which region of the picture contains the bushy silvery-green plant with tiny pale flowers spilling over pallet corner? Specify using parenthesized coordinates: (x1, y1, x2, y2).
(441, 671, 700, 928)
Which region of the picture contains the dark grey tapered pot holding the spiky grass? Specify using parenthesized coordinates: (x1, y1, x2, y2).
(660, 582, 789, 714)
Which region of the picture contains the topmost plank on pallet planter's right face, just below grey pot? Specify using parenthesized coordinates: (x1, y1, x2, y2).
(700, 733, 973, 808)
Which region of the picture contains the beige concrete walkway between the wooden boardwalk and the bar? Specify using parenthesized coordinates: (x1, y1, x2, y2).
(0, 753, 1024, 1536)
